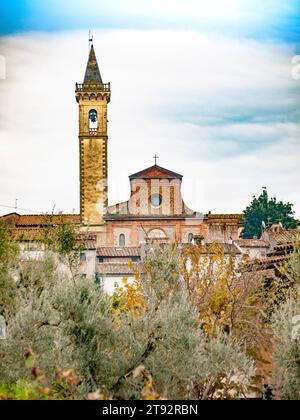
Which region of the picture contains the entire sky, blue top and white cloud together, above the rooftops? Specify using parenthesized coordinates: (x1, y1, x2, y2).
(0, 0, 300, 217)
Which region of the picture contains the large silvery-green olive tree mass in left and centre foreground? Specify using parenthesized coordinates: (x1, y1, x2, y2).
(0, 243, 254, 399)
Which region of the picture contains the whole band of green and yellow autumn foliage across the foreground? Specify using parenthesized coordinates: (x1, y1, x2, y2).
(0, 220, 300, 399)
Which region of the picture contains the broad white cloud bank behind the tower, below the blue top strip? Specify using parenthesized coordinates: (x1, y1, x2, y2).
(0, 30, 300, 215)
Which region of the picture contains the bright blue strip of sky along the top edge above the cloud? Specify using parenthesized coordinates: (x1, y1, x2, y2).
(0, 0, 300, 49)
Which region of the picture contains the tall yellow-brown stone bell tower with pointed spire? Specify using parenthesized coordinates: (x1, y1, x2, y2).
(75, 44, 110, 225)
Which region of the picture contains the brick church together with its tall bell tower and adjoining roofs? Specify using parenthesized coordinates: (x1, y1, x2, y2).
(3, 41, 242, 286)
